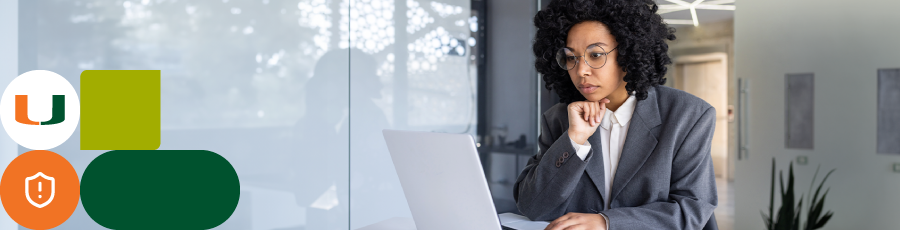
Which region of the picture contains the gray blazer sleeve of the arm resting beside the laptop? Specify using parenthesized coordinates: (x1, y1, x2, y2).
(601, 107, 718, 230)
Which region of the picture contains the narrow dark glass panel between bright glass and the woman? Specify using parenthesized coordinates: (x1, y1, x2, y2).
(479, 0, 536, 213)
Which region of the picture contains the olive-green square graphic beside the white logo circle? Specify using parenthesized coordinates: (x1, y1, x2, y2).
(81, 70, 160, 150)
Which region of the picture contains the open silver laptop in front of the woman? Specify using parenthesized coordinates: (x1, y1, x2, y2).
(383, 130, 547, 230)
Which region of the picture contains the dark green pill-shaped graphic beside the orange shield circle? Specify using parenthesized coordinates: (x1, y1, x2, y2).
(81, 150, 240, 229)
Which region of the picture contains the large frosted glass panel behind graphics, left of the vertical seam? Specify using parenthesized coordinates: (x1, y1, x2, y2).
(19, 0, 348, 229)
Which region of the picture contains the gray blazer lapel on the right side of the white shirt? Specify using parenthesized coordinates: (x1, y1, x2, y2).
(608, 87, 662, 204)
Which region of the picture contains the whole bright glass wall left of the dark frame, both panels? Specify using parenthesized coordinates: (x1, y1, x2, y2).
(18, 0, 479, 229)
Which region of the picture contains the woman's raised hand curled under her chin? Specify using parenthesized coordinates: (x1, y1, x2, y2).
(568, 98, 609, 145)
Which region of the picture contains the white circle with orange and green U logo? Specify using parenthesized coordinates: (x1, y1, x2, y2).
(0, 70, 81, 150)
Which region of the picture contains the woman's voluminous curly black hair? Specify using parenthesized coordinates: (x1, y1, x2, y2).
(532, 0, 675, 103)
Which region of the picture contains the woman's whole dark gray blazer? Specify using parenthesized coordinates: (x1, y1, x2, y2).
(513, 86, 718, 230)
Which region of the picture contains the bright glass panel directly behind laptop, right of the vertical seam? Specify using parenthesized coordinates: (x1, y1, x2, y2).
(341, 0, 479, 229)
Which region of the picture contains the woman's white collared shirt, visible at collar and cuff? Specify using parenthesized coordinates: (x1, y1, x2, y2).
(569, 95, 637, 209)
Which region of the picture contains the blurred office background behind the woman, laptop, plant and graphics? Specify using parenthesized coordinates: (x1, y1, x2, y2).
(0, 0, 900, 229)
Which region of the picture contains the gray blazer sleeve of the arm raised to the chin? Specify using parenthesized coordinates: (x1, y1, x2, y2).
(513, 114, 593, 221)
